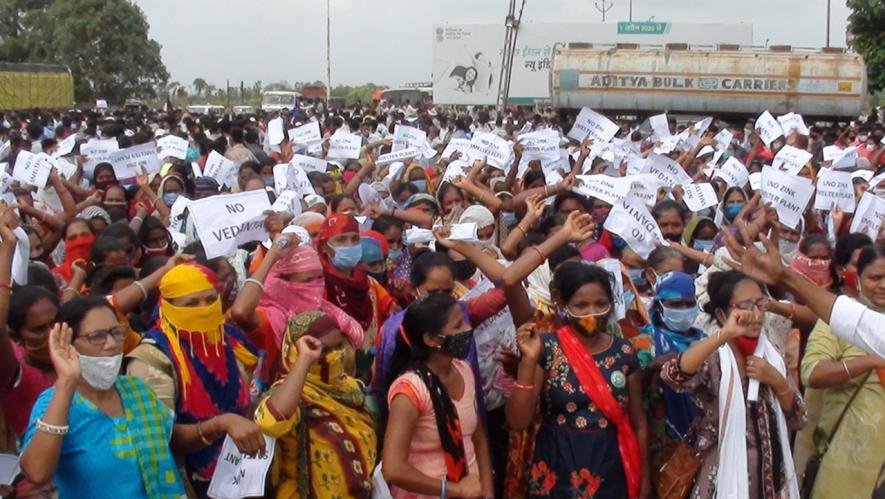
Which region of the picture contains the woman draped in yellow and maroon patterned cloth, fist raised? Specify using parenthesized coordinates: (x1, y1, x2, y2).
(255, 311, 378, 498)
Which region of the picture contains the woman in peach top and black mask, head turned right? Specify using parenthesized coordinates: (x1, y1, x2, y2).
(383, 293, 493, 498)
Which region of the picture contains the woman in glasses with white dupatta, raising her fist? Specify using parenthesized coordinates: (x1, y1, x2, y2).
(661, 271, 806, 499)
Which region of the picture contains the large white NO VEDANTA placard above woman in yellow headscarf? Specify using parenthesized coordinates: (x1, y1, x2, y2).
(188, 190, 271, 259)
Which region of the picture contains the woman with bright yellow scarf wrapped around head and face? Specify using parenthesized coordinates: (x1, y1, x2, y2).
(127, 264, 265, 497)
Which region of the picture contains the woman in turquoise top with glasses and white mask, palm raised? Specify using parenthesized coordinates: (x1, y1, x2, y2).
(21, 296, 184, 498)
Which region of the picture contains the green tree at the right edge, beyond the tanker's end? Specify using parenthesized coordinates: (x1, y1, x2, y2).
(848, 0, 885, 93)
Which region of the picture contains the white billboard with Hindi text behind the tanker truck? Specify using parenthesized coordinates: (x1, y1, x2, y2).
(433, 22, 753, 105)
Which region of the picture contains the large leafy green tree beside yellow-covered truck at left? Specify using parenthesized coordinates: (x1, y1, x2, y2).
(18, 0, 169, 103)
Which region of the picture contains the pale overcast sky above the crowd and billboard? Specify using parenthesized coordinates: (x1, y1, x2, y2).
(135, 0, 849, 86)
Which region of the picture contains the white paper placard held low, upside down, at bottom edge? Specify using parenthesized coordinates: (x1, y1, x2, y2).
(207, 435, 276, 499)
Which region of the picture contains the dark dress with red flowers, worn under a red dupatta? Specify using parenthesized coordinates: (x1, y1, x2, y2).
(529, 333, 639, 499)
